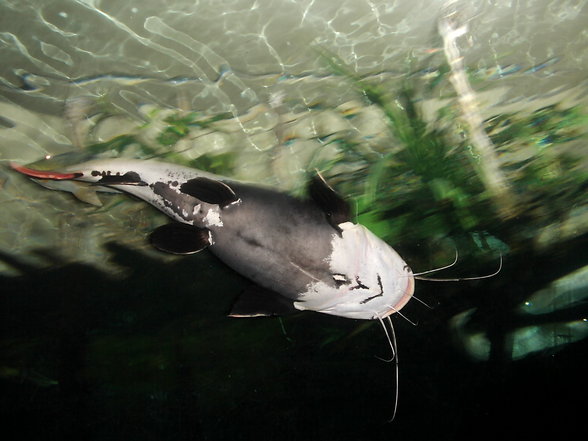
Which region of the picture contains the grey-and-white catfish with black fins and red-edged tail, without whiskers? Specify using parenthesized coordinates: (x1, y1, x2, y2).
(13, 159, 414, 319)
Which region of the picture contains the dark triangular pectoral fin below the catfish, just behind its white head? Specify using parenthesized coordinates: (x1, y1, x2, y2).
(229, 285, 298, 317)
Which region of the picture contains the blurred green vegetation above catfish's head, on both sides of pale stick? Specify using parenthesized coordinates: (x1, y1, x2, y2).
(322, 52, 588, 262)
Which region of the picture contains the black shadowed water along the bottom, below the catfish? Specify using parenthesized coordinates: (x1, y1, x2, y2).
(0, 237, 588, 440)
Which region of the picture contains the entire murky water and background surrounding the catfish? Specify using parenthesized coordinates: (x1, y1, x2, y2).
(0, 0, 588, 440)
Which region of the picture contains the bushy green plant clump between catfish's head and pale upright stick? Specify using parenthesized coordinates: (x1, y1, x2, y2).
(316, 55, 489, 241)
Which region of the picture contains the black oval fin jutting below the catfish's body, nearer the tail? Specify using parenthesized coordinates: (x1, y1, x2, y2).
(150, 222, 213, 254)
